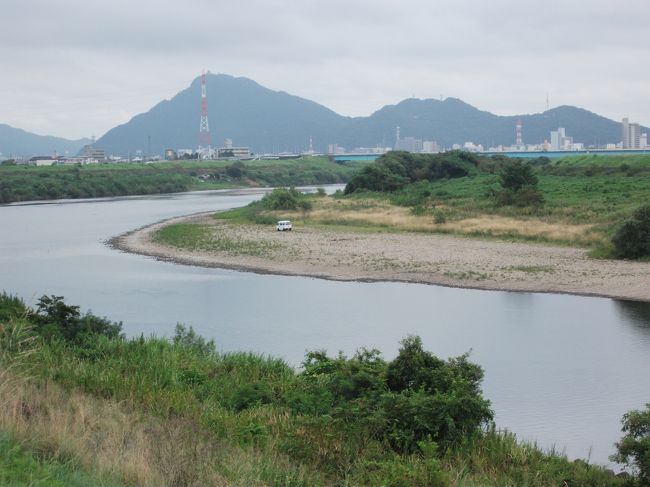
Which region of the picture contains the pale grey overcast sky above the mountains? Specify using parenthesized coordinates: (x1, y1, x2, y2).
(0, 0, 650, 138)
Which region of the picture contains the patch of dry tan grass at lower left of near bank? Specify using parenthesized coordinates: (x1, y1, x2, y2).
(0, 377, 228, 487)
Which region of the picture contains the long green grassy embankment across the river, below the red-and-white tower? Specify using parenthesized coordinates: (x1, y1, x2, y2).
(0, 157, 360, 203)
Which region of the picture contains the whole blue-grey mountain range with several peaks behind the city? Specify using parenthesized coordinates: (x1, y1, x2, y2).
(88, 74, 650, 156)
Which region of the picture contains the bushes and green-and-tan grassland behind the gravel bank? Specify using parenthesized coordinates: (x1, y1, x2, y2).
(215, 152, 650, 258)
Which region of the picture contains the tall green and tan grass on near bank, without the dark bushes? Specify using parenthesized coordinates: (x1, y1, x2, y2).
(0, 296, 621, 487)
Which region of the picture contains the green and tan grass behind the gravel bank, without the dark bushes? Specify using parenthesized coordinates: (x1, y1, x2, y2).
(215, 156, 650, 255)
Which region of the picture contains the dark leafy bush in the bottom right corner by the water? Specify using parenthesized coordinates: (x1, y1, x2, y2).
(611, 403, 650, 487)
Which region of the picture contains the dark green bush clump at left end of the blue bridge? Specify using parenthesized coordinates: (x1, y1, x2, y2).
(345, 151, 478, 194)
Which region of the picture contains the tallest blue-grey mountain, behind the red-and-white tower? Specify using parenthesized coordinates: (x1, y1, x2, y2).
(96, 74, 349, 155)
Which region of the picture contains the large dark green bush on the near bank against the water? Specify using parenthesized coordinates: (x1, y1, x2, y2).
(288, 337, 492, 453)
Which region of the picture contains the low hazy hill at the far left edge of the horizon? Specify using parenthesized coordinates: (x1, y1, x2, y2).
(0, 124, 90, 159)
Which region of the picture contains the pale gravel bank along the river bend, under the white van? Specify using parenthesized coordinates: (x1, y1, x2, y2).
(109, 214, 650, 301)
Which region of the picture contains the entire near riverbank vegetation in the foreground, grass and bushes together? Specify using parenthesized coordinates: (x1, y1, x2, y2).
(0, 295, 623, 487)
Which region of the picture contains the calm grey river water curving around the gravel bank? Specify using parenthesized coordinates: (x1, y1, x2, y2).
(0, 192, 650, 463)
